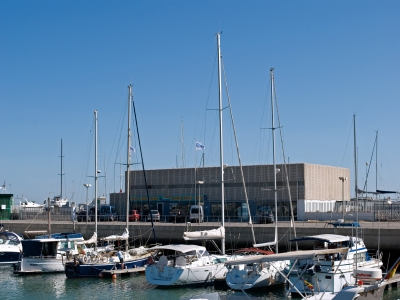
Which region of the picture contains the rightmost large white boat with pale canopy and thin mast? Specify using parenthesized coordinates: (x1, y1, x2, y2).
(287, 116, 382, 299)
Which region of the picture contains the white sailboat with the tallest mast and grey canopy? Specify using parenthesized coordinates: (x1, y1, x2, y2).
(145, 33, 239, 286)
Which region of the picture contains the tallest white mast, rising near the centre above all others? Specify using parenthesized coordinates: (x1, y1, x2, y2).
(217, 32, 225, 254)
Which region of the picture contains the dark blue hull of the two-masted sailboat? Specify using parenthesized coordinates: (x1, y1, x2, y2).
(64, 257, 148, 278)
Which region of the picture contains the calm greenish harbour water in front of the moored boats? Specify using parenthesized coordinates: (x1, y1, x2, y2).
(0, 266, 400, 300)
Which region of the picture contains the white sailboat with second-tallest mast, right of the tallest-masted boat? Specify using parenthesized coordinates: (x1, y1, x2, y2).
(226, 68, 290, 290)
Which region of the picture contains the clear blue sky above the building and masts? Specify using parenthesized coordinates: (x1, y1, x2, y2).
(0, 0, 400, 202)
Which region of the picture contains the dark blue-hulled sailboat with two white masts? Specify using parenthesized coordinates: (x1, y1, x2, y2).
(65, 85, 150, 278)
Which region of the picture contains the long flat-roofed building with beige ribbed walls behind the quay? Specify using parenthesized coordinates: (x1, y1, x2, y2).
(110, 163, 350, 222)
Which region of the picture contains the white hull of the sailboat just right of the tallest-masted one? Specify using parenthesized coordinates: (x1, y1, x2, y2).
(226, 261, 290, 290)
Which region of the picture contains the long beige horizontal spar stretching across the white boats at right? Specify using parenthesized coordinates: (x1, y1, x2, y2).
(225, 248, 348, 266)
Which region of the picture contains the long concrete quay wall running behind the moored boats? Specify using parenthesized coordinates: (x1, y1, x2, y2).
(1, 220, 400, 255)
